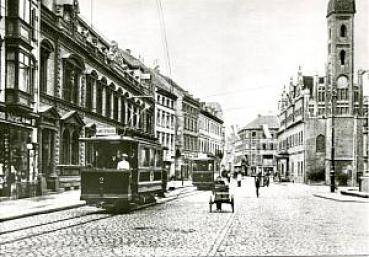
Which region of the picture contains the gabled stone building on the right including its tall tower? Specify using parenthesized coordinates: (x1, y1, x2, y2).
(278, 0, 367, 186)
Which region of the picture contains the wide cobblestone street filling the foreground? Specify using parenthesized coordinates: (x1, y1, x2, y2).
(0, 178, 369, 257)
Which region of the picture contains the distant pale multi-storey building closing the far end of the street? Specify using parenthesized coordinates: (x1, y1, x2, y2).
(235, 115, 279, 175)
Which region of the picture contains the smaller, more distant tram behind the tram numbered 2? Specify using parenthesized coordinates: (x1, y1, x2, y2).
(192, 157, 220, 190)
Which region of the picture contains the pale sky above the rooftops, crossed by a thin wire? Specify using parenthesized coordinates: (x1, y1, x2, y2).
(79, 0, 369, 127)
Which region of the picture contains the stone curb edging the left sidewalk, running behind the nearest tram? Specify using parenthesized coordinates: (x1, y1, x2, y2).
(0, 187, 196, 222)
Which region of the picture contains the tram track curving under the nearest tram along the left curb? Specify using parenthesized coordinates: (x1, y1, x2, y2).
(0, 187, 201, 246)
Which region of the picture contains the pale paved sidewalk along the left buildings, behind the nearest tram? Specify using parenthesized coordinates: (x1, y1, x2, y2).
(0, 183, 196, 222)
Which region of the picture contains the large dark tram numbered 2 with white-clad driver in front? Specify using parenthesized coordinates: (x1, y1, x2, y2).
(80, 132, 163, 211)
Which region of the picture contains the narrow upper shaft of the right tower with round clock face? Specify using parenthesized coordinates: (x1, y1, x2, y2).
(327, 0, 356, 116)
